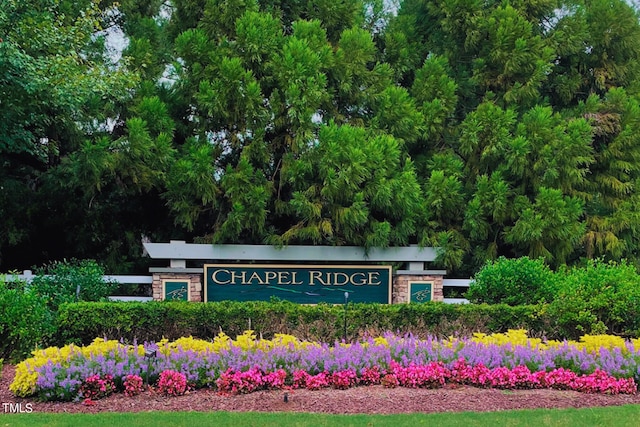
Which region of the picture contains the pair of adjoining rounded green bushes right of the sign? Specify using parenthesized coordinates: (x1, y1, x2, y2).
(466, 257, 640, 338)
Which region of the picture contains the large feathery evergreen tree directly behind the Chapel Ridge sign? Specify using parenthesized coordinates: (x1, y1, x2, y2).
(165, 1, 423, 246)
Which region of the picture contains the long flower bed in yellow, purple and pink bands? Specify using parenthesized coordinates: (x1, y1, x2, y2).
(10, 330, 640, 401)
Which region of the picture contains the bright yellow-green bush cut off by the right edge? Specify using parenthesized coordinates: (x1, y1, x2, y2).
(548, 260, 640, 338)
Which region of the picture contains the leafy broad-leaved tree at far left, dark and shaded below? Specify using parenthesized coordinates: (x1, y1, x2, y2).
(0, 0, 136, 268)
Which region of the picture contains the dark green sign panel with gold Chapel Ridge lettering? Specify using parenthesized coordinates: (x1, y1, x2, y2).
(204, 264, 391, 304)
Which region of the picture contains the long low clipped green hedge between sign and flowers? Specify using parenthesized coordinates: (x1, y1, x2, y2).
(58, 301, 548, 345)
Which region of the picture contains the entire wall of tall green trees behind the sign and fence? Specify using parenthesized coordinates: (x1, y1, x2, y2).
(0, 0, 640, 274)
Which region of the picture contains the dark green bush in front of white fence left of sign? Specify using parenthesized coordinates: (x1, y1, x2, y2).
(30, 259, 117, 311)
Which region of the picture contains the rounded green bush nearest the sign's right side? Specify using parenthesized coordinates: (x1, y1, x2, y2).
(466, 257, 556, 306)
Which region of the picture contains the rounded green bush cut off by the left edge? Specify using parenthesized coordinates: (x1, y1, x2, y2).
(0, 277, 54, 361)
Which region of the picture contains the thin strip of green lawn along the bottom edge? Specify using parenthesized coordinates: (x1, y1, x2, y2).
(0, 405, 640, 427)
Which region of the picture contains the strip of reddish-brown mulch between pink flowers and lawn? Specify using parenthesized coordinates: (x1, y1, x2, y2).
(0, 365, 640, 414)
